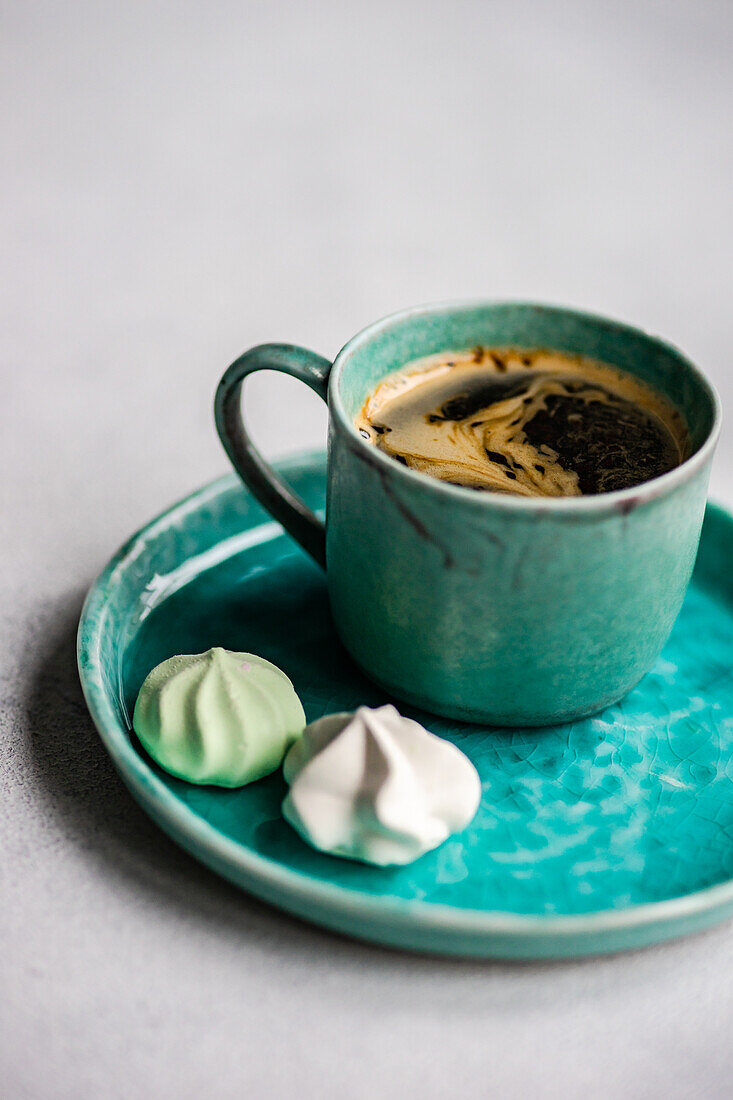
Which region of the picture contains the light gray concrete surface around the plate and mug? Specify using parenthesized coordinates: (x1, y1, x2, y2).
(0, 0, 733, 1100)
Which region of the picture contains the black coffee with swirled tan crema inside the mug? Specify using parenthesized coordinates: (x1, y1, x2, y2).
(354, 348, 690, 497)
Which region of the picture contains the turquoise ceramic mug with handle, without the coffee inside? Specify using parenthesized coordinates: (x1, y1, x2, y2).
(216, 303, 720, 726)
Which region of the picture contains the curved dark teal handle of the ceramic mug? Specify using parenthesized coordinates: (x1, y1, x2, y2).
(214, 344, 331, 569)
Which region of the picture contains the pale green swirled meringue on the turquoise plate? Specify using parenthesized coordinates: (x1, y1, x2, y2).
(132, 648, 305, 787)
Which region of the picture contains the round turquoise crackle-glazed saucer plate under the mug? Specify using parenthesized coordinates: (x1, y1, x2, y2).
(78, 454, 733, 958)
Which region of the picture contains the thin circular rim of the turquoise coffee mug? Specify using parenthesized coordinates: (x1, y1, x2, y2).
(328, 298, 722, 516)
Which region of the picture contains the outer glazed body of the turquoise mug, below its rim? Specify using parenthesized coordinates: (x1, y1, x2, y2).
(327, 429, 708, 726)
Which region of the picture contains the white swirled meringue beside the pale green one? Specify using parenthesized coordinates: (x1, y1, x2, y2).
(283, 706, 481, 866)
